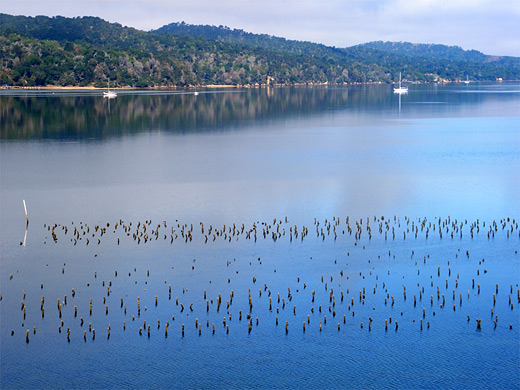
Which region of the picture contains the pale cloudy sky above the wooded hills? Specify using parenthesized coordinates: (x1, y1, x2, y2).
(0, 0, 520, 56)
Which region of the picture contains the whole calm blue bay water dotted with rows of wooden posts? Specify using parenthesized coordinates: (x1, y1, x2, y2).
(0, 83, 520, 388)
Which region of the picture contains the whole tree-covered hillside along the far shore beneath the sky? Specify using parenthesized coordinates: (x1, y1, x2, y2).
(0, 14, 520, 88)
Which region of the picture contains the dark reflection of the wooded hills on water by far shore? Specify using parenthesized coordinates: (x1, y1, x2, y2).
(0, 86, 516, 140)
